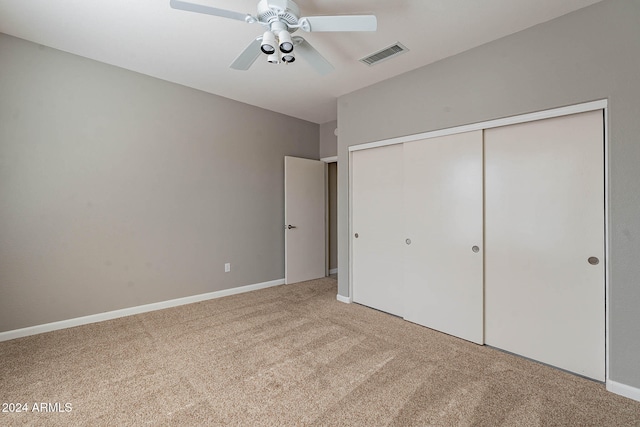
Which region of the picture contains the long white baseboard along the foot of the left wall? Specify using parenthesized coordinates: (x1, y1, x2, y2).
(0, 279, 284, 342)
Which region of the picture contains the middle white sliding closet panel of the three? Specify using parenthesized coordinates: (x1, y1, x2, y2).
(404, 131, 484, 344)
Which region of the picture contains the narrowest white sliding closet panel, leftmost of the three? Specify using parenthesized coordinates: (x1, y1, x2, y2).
(351, 144, 404, 316)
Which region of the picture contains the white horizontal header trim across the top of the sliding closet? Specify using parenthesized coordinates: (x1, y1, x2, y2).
(349, 99, 607, 152)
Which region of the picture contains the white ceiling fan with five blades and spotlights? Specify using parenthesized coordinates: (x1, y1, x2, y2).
(170, 0, 378, 75)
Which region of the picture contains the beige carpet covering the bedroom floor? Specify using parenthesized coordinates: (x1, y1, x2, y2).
(0, 279, 640, 426)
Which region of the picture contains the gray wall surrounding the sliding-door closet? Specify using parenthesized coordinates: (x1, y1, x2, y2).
(338, 0, 640, 387)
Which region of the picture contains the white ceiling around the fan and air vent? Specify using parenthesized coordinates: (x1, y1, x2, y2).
(0, 0, 600, 123)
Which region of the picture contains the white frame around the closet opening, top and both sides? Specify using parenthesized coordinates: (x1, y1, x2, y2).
(348, 99, 615, 382)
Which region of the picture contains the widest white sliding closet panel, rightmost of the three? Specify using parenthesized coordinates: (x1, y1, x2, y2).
(485, 111, 605, 381)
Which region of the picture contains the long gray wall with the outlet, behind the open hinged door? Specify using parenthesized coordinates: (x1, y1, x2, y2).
(0, 35, 319, 331)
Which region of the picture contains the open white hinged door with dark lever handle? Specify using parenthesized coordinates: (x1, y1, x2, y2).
(284, 156, 325, 284)
